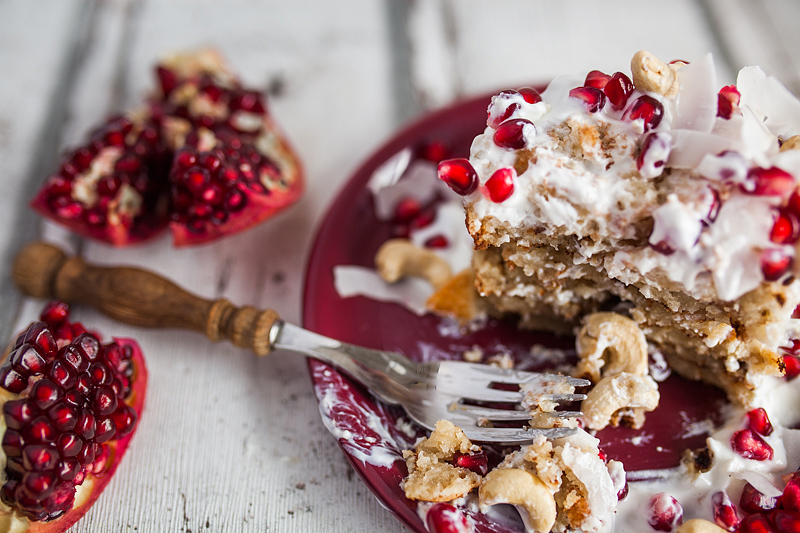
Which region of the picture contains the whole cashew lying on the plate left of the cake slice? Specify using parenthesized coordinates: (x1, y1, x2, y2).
(375, 239, 453, 289)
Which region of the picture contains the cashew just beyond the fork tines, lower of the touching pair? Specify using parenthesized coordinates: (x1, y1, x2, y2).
(581, 372, 660, 429)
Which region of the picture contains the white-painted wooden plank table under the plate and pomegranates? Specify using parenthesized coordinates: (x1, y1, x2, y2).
(0, 0, 800, 533)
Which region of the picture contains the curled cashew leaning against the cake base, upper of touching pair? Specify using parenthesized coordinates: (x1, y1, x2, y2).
(575, 313, 648, 383)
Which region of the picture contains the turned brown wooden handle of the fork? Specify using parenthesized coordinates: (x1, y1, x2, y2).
(11, 242, 280, 355)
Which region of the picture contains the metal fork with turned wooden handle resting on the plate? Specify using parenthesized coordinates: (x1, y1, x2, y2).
(11, 242, 590, 445)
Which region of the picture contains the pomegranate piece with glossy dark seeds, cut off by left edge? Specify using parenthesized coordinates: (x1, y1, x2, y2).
(0, 302, 147, 532)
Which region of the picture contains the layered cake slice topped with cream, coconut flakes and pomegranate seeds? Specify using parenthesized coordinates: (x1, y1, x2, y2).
(439, 52, 800, 405)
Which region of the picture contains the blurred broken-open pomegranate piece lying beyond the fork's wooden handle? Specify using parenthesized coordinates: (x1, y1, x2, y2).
(31, 50, 304, 246)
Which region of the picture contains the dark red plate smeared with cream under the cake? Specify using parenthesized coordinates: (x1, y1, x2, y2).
(303, 92, 725, 533)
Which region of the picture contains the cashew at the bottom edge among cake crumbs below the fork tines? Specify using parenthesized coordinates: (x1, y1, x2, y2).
(478, 468, 556, 533)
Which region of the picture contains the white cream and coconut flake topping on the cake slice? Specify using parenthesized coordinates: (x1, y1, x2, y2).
(465, 55, 800, 301)
